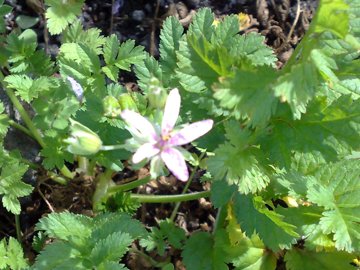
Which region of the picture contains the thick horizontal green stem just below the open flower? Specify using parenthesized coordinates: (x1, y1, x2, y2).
(131, 191, 210, 203)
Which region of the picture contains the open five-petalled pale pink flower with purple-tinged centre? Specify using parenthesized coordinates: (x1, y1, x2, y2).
(121, 88, 213, 181)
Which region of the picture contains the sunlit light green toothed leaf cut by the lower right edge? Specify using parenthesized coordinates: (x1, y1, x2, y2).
(307, 160, 360, 252)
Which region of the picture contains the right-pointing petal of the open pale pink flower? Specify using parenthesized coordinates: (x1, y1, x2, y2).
(168, 119, 214, 146)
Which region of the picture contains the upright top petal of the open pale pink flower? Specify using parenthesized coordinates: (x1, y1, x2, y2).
(161, 88, 181, 135)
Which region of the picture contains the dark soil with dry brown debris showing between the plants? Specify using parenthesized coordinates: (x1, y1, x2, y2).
(0, 0, 317, 269)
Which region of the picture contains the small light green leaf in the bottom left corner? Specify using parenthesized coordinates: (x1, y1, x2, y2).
(0, 237, 28, 270)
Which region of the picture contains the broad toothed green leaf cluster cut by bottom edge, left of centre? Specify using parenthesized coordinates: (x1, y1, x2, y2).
(33, 212, 146, 269)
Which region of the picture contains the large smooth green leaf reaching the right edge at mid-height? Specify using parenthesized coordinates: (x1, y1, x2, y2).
(261, 96, 360, 167)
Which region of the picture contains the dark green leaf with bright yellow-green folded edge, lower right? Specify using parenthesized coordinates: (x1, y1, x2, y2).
(234, 194, 299, 251)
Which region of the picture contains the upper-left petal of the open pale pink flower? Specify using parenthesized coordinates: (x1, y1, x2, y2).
(120, 110, 157, 140)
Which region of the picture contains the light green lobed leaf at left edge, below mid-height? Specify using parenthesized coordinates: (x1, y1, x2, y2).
(0, 146, 33, 215)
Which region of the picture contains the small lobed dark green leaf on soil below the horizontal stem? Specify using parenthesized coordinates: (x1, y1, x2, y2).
(140, 219, 185, 256)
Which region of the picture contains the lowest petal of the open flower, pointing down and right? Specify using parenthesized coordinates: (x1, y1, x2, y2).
(160, 148, 189, 181)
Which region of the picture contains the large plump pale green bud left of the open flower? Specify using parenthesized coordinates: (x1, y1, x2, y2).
(64, 119, 102, 156)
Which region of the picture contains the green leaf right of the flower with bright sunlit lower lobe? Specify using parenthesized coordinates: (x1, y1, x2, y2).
(207, 122, 270, 194)
